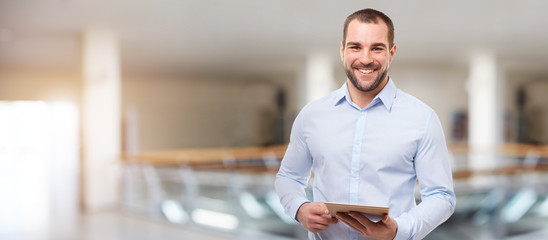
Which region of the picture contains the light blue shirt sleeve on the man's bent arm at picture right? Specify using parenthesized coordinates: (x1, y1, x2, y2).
(394, 112, 456, 239)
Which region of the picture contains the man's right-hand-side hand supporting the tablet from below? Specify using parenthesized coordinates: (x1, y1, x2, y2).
(337, 212, 398, 239)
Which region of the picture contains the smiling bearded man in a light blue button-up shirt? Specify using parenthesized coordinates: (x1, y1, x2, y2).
(275, 9, 456, 239)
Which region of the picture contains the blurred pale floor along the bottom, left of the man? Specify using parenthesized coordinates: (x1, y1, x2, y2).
(0, 211, 296, 240)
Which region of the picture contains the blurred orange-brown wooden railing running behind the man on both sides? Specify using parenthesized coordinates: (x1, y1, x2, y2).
(122, 143, 548, 176)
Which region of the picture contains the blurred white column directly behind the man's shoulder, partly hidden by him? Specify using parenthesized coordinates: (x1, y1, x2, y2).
(298, 53, 336, 109)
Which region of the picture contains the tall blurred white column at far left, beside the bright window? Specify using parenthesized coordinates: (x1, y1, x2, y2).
(82, 29, 121, 211)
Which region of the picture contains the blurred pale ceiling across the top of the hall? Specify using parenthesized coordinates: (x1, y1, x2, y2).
(0, 0, 548, 73)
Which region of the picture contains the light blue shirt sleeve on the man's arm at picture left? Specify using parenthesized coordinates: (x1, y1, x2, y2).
(274, 110, 312, 220)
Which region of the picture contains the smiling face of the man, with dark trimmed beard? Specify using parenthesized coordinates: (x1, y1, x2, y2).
(341, 20, 396, 92)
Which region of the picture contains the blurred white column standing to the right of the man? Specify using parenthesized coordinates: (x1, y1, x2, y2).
(468, 53, 504, 169)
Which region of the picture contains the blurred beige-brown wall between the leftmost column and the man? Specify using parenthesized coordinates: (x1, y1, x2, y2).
(122, 76, 296, 150)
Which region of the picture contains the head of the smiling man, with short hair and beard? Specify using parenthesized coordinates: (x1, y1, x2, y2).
(340, 9, 396, 95)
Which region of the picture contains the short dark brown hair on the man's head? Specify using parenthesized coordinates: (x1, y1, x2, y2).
(343, 8, 394, 48)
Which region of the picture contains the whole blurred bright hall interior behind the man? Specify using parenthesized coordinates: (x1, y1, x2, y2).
(0, 0, 548, 239)
